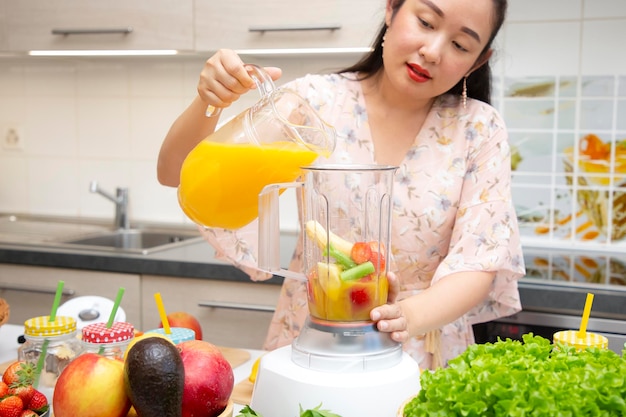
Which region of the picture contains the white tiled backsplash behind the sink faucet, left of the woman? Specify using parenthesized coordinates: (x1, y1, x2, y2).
(0, 53, 353, 228)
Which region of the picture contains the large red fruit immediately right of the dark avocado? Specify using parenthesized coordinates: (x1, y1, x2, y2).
(177, 340, 234, 417)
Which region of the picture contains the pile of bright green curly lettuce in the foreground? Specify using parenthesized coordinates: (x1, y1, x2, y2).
(404, 333, 626, 417)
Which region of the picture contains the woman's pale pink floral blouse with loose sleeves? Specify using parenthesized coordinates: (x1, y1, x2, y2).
(202, 74, 525, 369)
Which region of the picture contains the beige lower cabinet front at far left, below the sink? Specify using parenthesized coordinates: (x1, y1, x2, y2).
(0, 264, 141, 327)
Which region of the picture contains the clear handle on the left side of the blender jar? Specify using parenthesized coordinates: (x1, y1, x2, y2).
(258, 182, 306, 281)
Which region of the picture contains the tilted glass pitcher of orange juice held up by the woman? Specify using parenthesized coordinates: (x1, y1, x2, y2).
(178, 64, 335, 229)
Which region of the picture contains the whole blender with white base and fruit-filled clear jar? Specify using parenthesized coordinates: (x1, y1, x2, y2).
(250, 165, 420, 417)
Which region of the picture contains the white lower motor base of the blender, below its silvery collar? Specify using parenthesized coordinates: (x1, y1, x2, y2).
(250, 322, 420, 417)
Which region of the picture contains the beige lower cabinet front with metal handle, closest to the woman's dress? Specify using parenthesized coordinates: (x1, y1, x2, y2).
(141, 275, 281, 349)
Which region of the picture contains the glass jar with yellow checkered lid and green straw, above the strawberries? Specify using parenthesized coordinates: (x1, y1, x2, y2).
(17, 316, 82, 401)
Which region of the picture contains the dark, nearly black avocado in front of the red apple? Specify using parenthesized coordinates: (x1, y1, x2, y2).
(124, 337, 185, 417)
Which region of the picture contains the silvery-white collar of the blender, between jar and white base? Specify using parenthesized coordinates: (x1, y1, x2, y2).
(291, 317, 403, 372)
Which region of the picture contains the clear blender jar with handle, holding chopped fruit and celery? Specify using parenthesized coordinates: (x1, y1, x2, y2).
(258, 165, 397, 322)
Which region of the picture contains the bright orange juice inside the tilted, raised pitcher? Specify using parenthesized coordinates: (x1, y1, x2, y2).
(178, 140, 318, 229)
